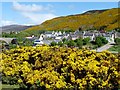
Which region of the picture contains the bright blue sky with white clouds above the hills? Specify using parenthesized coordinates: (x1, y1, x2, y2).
(0, 2, 118, 26)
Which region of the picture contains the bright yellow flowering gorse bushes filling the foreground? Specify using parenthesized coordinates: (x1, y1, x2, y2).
(1, 46, 120, 90)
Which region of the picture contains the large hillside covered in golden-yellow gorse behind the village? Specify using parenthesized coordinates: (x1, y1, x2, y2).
(27, 8, 120, 31)
